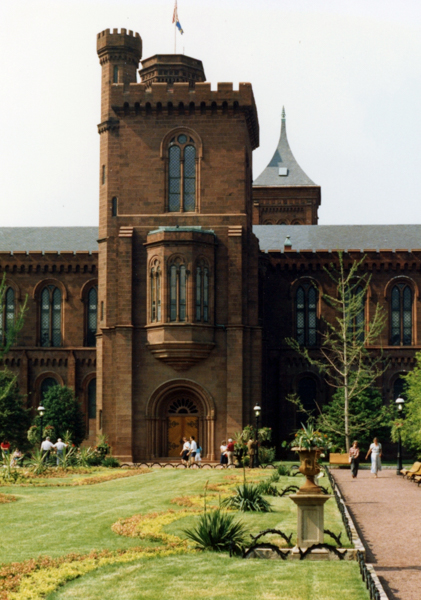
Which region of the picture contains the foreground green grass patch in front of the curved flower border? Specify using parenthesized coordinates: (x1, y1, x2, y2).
(49, 552, 368, 600)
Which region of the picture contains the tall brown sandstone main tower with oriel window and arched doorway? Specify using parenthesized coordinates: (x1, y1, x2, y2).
(97, 30, 261, 460)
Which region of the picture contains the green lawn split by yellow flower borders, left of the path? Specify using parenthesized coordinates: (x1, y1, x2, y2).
(0, 469, 368, 600)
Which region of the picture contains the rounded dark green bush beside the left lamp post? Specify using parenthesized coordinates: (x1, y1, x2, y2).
(35, 385, 85, 446)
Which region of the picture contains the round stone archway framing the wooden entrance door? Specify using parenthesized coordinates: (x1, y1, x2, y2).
(146, 379, 215, 460)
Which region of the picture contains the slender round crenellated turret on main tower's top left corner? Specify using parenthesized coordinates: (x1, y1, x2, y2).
(97, 29, 142, 121)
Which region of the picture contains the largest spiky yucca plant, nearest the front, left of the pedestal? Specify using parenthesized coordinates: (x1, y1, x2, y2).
(184, 508, 246, 554)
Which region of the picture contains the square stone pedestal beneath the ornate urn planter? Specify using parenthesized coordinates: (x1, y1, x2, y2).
(290, 493, 332, 548)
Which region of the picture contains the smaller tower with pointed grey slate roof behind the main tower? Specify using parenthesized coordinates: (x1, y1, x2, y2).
(253, 108, 321, 225)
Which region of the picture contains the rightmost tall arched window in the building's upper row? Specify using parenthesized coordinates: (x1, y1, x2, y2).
(390, 283, 413, 346)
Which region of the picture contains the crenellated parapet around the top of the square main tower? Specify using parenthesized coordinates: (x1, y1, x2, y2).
(100, 82, 259, 149)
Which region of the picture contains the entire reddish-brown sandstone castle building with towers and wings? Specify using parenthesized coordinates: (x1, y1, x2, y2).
(0, 30, 421, 461)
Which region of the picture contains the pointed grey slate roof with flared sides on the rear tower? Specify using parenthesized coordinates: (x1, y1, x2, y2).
(253, 108, 317, 187)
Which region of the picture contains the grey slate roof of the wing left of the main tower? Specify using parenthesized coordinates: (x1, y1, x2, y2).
(0, 227, 98, 252)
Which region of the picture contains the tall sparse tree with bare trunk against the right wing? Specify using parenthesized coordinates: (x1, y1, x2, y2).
(287, 253, 386, 451)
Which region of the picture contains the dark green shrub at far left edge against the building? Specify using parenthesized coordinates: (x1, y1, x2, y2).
(0, 371, 31, 450)
